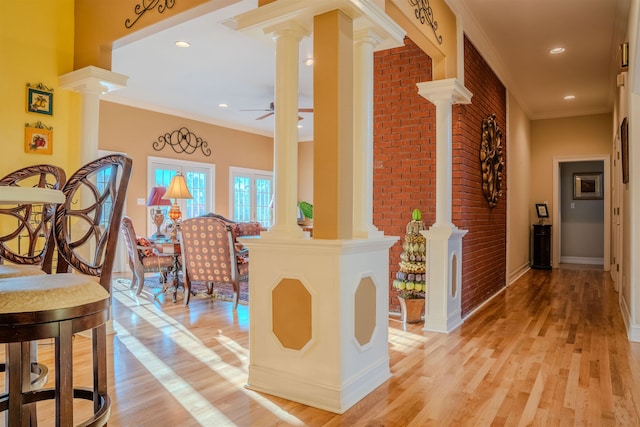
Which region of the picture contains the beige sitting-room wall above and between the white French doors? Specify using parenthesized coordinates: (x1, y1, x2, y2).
(99, 101, 273, 232)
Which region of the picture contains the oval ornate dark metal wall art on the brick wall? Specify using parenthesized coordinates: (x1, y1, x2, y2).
(480, 114, 504, 208)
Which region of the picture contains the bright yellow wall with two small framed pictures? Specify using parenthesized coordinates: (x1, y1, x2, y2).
(0, 0, 80, 176)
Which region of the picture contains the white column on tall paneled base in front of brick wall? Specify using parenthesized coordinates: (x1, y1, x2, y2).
(417, 79, 472, 332)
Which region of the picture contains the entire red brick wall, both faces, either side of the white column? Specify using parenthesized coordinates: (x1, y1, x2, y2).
(373, 38, 506, 315)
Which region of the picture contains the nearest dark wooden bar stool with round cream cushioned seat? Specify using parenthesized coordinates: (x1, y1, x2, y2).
(0, 155, 132, 426)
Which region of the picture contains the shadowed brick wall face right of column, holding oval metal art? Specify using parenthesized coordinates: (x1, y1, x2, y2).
(452, 37, 508, 316)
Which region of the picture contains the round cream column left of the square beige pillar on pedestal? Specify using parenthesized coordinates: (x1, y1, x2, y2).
(262, 21, 309, 238)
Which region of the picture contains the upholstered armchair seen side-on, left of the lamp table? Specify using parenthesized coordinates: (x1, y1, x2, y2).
(120, 216, 174, 295)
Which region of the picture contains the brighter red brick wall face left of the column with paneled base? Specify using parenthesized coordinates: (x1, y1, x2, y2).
(373, 38, 436, 312)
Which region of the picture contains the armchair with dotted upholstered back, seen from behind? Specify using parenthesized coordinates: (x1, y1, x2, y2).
(180, 217, 249, 309)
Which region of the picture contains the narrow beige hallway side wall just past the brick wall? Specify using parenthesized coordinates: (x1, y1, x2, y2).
(507, 94, 532, 283)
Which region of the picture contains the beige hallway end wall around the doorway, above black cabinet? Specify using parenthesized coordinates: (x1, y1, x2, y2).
(528, 113, 613, 227)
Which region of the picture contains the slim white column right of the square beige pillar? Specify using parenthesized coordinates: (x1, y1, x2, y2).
(353, 29, 384, 239)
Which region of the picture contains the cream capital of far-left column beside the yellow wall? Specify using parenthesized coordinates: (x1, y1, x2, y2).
(58, 65, 129, 95)
